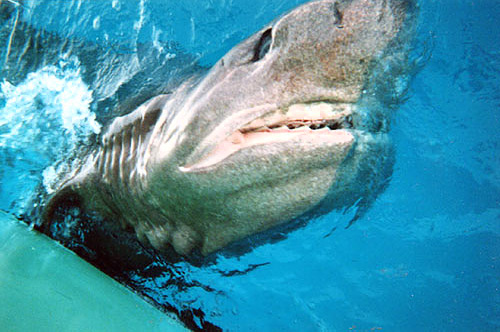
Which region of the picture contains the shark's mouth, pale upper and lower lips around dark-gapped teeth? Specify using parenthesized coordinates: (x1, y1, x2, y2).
(180, 101, 355, 173)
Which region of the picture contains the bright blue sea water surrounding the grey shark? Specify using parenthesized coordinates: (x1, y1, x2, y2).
(0, 0, 500, 331)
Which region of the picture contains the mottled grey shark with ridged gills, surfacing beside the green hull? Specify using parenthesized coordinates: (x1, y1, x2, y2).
(44, 0, 416, 255)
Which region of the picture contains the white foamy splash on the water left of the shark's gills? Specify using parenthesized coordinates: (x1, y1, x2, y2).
(0, 57, 101, 206)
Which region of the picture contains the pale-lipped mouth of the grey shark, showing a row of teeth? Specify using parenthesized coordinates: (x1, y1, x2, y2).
(179, 101, 355, 173)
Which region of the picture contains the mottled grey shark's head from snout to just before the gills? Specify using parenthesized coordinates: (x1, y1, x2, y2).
(130, 0, 414, 254)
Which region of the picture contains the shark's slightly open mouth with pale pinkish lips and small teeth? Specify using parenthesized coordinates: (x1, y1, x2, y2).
(181, 101, 354, 172)
